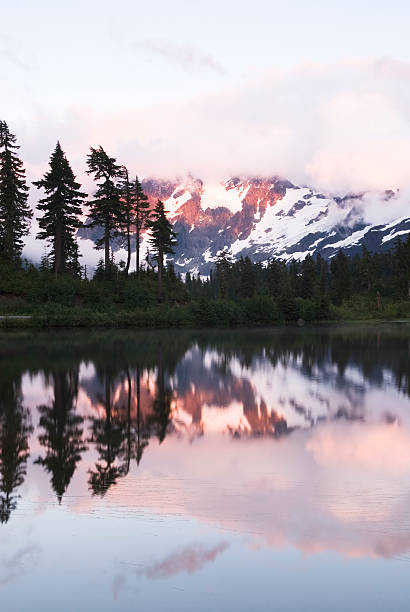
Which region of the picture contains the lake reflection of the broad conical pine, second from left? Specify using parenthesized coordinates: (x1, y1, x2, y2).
(36, 367, 87, 502)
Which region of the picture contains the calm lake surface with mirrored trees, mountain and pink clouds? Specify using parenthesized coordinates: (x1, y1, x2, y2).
(0, 324, 410, 612)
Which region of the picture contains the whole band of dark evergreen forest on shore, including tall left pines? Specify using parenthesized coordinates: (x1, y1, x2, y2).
(0, 121, 410, 327)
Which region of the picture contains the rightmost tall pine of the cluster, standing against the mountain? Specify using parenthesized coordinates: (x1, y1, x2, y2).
(146, 200, 176, 300)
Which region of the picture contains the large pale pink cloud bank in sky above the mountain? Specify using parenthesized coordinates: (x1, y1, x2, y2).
(13, 56, 410, 206)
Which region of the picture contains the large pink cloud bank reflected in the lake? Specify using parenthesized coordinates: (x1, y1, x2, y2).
(88, 422, 410, 559)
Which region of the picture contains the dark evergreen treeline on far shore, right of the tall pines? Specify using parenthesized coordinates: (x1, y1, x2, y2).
(185, 241, 410, 323)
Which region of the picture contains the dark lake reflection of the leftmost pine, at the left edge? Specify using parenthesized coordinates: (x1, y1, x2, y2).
(0, 377, 33, 523)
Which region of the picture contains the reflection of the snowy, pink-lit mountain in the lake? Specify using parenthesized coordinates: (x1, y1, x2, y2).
(77, 332, 410, 439)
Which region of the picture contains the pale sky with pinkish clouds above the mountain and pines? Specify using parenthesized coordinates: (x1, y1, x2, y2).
(0, 0, 410, 193)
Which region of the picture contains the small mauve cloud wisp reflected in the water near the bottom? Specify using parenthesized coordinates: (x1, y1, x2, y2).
(141, 542, 229, 580)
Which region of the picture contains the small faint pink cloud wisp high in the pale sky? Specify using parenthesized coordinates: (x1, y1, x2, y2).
(137, 38, 226, 75)
